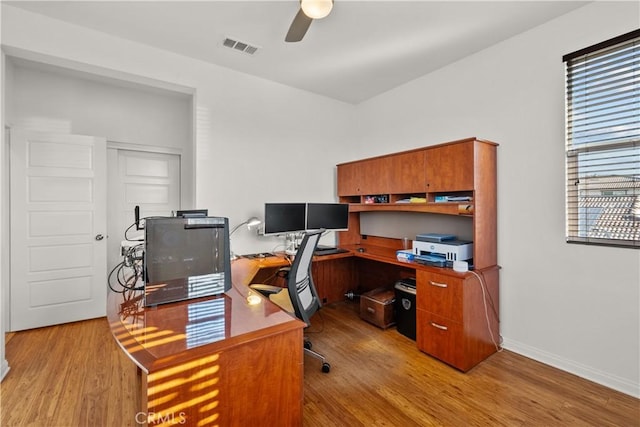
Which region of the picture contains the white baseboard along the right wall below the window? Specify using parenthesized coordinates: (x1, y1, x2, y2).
(502, 338, 640, 398)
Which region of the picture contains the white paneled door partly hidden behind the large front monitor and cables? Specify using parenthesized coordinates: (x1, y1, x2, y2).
(107, 148, 180, 283)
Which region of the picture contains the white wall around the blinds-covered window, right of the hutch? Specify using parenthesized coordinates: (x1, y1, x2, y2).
(358, 2, 640, 396)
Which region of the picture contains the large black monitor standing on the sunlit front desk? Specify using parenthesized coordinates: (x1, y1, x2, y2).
(144, 217, 231, 306)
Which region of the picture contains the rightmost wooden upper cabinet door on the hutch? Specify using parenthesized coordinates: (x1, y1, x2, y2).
(425, 141, 474, 193)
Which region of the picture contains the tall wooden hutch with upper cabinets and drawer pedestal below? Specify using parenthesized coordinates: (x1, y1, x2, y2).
(336, 138, 499, 371)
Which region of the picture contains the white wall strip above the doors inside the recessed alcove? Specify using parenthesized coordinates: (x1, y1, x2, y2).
(5, 58, 192, 152)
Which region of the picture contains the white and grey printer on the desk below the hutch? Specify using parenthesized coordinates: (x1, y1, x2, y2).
(413, 233, 473, 267)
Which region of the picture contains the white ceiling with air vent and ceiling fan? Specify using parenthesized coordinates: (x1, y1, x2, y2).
(3, 0, 586, 104)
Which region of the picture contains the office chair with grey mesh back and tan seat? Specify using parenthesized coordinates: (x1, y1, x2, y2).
(250, 230, 331, 373)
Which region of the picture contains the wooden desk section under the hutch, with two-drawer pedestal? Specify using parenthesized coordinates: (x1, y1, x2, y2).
(344, 245, 500, 372)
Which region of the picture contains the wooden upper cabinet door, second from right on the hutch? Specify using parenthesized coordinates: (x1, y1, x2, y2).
(389, 150, 425, 194)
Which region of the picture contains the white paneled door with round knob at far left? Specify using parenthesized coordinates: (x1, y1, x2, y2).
(9, 129, 107, 331)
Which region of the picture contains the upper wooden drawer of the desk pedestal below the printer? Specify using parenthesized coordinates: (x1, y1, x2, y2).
(417, 271, 465, 322)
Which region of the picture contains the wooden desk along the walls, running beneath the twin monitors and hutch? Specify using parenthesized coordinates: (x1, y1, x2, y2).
(258, 241, 500, 371)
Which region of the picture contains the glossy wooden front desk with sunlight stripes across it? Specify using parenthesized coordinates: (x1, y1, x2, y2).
(107, 268, 305, 426)
